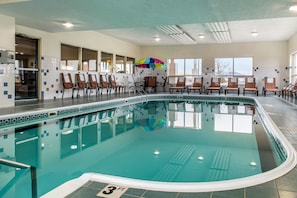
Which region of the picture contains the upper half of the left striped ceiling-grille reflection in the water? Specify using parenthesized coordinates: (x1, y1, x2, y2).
(170, 145, 195, 165)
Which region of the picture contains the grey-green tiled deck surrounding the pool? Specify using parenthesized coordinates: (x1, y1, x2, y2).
(0, 94, 297, 198)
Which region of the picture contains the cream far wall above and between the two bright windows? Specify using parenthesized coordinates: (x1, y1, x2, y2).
(142, 41, 289, 92)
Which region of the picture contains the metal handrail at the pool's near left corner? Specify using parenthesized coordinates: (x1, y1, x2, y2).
(0, 158, 37, 198)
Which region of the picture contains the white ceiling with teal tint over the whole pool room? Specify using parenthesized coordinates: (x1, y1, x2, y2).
(0, 0, 297, 46)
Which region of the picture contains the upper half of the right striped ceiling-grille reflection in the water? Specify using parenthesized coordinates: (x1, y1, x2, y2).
(210, 148, 231, 170)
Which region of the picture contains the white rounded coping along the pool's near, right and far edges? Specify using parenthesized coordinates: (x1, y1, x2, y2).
(39, 94, 297, 197)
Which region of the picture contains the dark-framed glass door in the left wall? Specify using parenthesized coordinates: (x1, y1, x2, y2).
(15, 35, 38, 100)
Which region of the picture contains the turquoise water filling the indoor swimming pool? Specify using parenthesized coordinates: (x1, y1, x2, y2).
(0, 101, 286, 197)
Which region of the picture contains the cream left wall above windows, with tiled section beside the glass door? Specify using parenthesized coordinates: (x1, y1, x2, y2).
(16, 25, 140, 99)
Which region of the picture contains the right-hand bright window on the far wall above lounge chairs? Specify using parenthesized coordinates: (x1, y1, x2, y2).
(215, 57, 253, 76)
